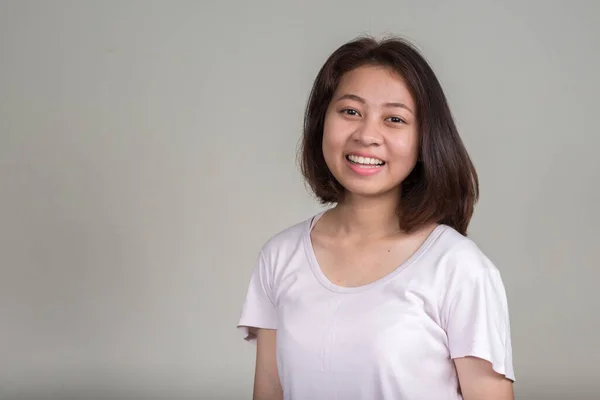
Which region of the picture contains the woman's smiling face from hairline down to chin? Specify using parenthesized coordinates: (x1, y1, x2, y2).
(323, 66, 419, 200)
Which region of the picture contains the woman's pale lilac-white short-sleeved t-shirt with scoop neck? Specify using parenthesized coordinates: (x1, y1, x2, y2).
(238, 213, 514, 400)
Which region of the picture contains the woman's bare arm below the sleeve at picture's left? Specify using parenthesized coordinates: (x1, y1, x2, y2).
(253, 329, 283, 400)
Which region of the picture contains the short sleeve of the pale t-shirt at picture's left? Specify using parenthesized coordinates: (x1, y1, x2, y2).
(237, 251, 277, 343)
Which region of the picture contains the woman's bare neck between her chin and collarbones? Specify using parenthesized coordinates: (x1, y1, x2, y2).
(331, 190, 400, 238)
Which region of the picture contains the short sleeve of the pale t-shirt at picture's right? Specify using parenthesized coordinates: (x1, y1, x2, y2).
(442, 239, 515, 381)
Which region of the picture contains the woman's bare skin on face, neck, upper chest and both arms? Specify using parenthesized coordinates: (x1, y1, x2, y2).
(254, 66, 514, 400)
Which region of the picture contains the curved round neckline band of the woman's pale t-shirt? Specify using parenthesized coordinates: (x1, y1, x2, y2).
(304, 210, 447, 293)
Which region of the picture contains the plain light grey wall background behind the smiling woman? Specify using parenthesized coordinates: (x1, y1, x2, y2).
(0, 0, 600, 399)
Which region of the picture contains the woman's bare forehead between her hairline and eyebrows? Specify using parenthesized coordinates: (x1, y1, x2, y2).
(334, 65, 414, 106)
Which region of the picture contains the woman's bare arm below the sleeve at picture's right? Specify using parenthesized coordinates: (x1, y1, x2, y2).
(454, 357, 514, 400)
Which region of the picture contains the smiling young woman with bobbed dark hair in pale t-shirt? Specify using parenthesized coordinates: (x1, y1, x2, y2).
(238, 38, 514, 400)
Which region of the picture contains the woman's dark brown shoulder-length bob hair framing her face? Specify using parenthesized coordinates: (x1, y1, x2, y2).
(299, 37, 479, 235)
